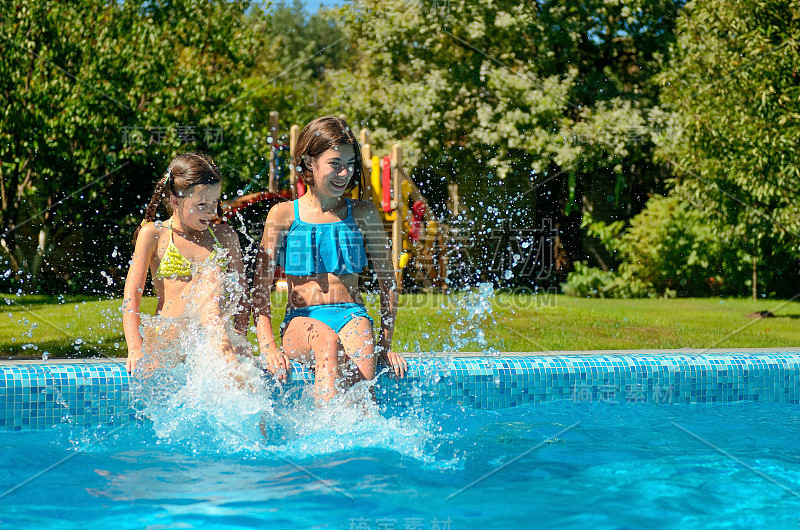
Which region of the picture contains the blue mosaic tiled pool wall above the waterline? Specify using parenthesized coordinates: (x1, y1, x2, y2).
(0, 348, 800, 431)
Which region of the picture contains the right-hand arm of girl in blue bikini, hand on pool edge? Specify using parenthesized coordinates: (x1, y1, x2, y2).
(359, 201, 408, 377)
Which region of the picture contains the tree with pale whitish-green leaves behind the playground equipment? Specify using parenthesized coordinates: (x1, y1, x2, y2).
(328, 0, 682, 282)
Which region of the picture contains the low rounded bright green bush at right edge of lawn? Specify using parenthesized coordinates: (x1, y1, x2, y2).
(563, 195, 796, 298)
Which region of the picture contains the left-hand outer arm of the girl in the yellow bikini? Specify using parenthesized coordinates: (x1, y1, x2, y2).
(122, 223, 158, 373)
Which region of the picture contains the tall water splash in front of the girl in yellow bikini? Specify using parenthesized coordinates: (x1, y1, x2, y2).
(132, 258, 269, 451)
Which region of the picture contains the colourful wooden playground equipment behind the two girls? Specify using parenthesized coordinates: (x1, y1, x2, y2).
(223, 117, 447, 292)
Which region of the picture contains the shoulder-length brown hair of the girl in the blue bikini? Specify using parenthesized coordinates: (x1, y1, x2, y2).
(293, 116, 364, 199)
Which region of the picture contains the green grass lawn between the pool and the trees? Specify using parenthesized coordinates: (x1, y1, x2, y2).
(0, 293, 800, 357)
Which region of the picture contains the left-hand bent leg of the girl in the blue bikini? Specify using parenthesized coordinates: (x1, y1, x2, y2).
(283, 317, 344, 401)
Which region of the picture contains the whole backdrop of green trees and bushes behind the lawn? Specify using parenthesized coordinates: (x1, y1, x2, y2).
(7, 0, 800, 302)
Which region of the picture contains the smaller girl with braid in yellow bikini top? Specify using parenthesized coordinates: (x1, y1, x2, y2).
(122, 153, 250, 373)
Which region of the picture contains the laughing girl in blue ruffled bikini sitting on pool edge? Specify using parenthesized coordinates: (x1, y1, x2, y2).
(253, 116, 407, 401)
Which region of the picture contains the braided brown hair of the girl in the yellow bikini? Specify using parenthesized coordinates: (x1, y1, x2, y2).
(133, 151, 222, 246)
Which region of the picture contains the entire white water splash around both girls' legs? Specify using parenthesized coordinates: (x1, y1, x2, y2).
(131, 260, 446, 465)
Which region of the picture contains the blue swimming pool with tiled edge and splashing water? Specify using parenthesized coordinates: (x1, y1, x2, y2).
(0, 350, 800, 530)
